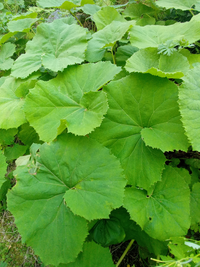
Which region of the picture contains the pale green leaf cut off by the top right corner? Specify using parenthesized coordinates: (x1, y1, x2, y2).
(156, 0, 200, 10)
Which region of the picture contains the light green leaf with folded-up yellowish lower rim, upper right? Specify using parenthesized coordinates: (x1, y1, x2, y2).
(125, 48, 190, 78)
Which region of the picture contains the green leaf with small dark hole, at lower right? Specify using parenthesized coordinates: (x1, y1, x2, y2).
(124, 166, 190, 241)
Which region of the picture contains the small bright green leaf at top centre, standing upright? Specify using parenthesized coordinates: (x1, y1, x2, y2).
(92, 6, 125, 30)
